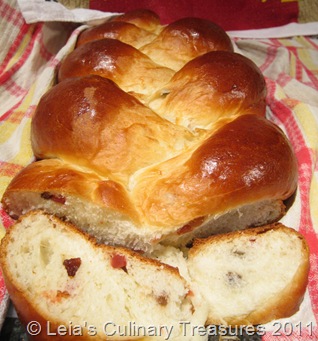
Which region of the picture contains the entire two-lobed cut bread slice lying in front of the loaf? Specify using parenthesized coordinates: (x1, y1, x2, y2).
(0, 211, 309, 340)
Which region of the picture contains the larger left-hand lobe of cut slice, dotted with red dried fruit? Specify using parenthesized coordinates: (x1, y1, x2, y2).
(0, 211, 206, 340)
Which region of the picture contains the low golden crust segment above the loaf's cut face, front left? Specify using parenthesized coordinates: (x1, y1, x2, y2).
(1, 159, 140, 224)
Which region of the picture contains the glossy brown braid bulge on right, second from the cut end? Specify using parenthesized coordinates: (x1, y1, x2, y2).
(148, 51, 266, 130)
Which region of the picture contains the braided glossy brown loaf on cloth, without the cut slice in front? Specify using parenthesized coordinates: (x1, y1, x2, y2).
(2, 11, 297, 251)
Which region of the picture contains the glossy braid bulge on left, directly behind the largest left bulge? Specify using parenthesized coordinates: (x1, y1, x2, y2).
(58, 38, 173, 99)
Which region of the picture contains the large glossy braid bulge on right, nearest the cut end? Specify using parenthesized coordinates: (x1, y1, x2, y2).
(133, 115, 297, 226)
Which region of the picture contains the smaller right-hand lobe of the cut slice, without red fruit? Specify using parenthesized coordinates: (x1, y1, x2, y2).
(188, 223, 309, 325)
